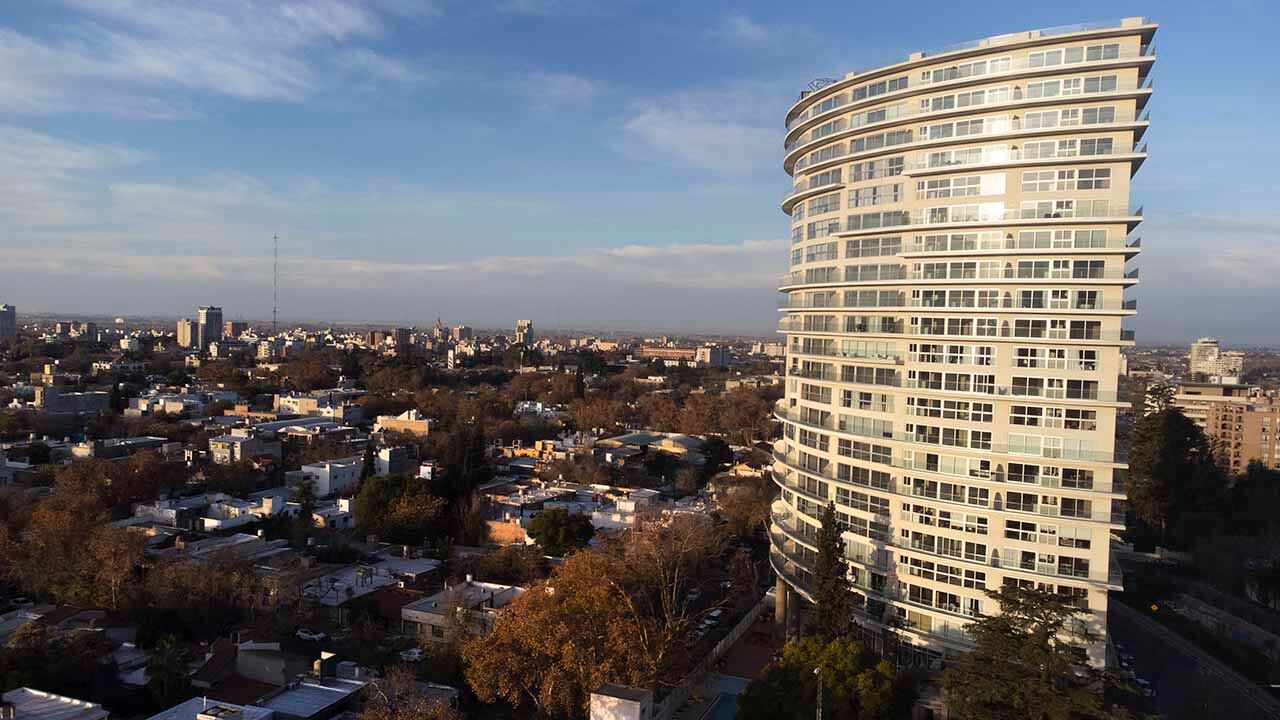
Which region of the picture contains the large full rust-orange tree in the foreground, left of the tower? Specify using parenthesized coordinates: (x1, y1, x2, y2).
(462, 552, 657, 717)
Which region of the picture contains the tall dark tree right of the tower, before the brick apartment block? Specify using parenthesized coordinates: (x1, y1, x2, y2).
(1125, 407, 1224, 547)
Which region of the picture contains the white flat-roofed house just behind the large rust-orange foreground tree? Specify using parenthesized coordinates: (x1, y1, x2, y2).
(401, 575, 526, 642)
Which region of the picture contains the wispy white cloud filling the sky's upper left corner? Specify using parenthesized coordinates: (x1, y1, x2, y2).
(0, 0, 434, 118)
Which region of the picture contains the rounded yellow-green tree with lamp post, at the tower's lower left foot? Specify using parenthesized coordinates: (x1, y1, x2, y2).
(737, 635, 914, 720)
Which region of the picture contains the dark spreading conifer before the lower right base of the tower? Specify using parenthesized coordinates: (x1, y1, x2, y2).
(942, 585, 1126, 720)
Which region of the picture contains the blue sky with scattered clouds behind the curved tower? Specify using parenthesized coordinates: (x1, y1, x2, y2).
(0, 0, 1280, 343)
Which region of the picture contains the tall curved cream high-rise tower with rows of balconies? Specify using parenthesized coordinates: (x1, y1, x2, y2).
(771, 18, 1156, 665)
